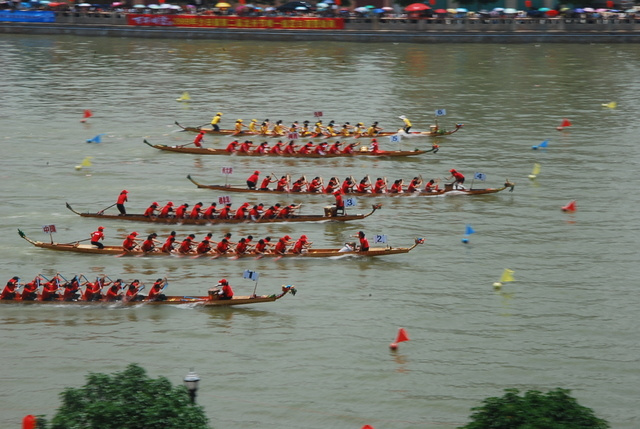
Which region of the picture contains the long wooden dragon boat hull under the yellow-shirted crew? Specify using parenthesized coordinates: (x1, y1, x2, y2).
(175, 121, 464, 139)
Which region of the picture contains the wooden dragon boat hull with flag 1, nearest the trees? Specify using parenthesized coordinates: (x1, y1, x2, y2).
(0, 285, 297, 307)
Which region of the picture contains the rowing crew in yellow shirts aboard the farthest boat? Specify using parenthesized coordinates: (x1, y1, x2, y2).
(211, 112, 396, 138)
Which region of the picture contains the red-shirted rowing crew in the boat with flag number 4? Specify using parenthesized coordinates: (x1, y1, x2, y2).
(242, 169, 465, 195)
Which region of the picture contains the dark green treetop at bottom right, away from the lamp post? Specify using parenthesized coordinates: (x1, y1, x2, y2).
(460, 388, 609, 429)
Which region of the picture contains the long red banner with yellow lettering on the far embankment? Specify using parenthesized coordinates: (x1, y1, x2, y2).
(127, 14, 344, 30)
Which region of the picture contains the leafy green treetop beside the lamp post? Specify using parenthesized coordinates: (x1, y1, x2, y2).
(38, 364, 208, 429)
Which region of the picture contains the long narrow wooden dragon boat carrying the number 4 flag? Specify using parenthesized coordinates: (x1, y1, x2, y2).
(187, 175, 515, 197)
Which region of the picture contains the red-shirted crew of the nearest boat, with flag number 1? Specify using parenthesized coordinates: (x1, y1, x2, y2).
(0, 273, 233, 302)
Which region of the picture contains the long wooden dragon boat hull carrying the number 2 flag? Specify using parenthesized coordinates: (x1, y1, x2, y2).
(18, 229, 424, 259)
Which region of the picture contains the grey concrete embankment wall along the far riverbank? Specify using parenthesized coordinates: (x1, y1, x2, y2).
(0, 12, 640, 43)
